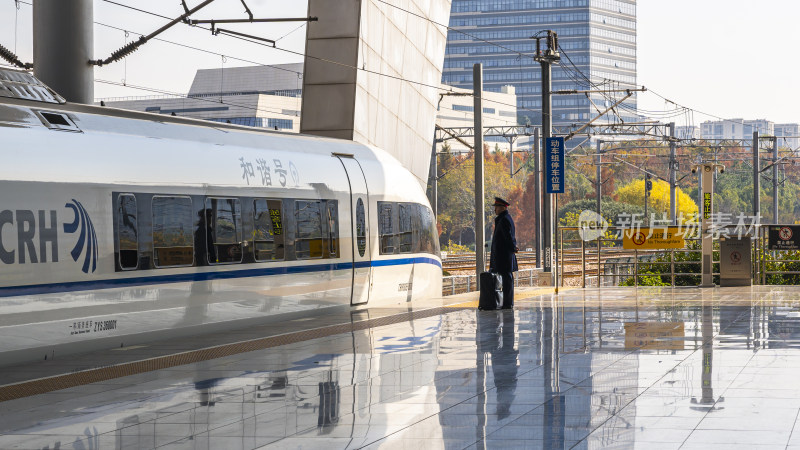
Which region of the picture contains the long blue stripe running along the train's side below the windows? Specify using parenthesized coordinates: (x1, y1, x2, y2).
(0, 257, 442, 297)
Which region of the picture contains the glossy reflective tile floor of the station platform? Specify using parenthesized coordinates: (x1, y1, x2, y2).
(6, 287, 800, 450)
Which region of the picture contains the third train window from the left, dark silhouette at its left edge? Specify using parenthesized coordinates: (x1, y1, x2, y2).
(204, 197, 242, 264)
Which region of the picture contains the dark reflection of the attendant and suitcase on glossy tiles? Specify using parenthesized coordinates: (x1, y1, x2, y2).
(478, 310, 519, 420)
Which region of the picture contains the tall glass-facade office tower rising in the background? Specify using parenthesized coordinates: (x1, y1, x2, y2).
(442, 0, 638, 125)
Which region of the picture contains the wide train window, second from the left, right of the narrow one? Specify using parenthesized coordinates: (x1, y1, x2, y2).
(152, 195, 194, 267)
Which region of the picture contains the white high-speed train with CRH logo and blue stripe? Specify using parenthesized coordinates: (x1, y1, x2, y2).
(0, 70, 442, 364)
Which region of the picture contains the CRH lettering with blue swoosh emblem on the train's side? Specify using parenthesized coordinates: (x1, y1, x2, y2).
(0, 199, 98, 273)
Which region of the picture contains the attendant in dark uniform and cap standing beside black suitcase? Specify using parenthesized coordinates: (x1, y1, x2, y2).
(489, 197, 519, 309)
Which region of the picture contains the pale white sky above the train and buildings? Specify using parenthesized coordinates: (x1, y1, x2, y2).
(0, 0, 800, 125)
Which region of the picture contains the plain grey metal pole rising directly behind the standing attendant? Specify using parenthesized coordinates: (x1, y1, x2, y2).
(472, 63, 486, 284)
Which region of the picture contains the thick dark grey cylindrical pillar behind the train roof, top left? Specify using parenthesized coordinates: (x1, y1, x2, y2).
(33, 0, 94, 103)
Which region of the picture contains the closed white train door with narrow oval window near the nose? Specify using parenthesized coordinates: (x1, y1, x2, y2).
(335, 154, 372, 305)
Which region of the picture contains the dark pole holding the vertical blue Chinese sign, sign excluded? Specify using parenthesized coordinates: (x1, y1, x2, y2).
(533, 30, 561, 282)
